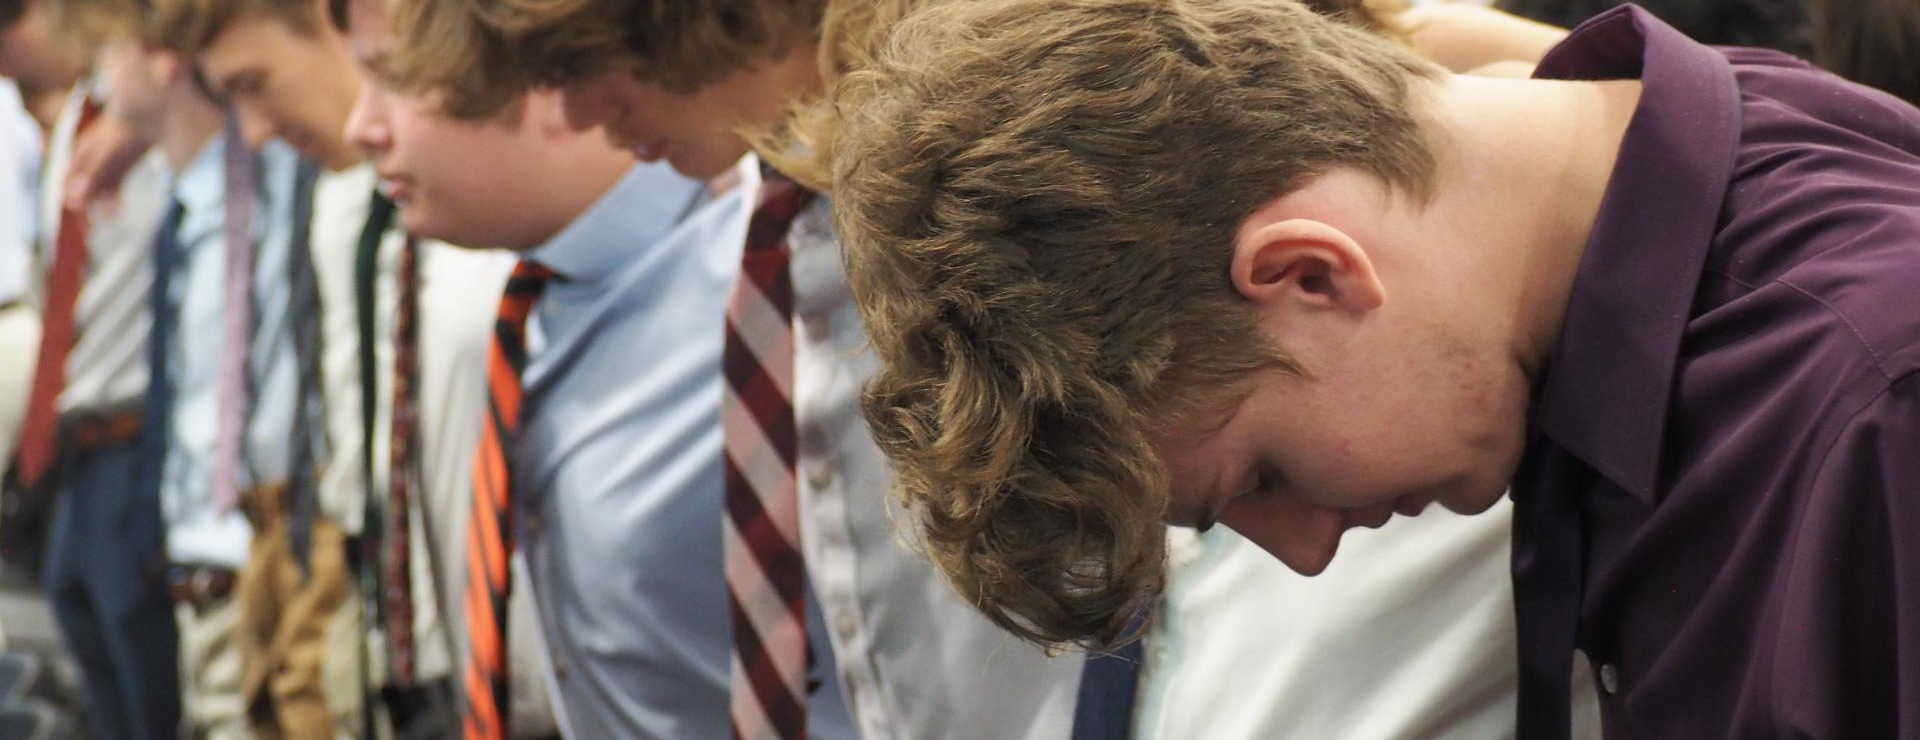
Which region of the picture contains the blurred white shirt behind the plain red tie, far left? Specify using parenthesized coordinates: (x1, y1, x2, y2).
(36, 83, 173, 413)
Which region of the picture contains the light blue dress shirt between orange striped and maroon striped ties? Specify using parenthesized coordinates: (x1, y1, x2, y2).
(513, 163, 856, 740)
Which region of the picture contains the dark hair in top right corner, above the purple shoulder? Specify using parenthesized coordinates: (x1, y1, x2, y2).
(1809, 0, 1920, 106)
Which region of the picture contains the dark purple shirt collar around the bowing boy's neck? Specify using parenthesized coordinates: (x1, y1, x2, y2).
(1532, 6, 1740, 504)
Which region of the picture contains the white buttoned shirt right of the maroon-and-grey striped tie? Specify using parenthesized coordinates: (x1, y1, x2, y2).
(779, 165, 1085, 740)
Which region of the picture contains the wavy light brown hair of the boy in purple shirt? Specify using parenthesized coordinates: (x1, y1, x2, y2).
(833, 0, 1440, 646)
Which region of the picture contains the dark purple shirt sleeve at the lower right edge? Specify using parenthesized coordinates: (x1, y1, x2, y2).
(1749, 375, 1920, 738)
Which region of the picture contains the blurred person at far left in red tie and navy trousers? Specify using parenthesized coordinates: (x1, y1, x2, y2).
(4, 2, 180, 738)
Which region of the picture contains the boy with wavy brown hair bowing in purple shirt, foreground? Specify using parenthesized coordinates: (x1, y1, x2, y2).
(833, 0, 1920, 738)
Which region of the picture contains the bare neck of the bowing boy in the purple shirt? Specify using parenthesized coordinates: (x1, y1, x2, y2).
(1427, 75, 1640, 379)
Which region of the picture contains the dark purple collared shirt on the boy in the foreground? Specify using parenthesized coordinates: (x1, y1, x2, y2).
(1513, 6, 1920, 740)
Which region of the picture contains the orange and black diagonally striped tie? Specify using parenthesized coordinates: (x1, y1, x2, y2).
(461, 259, 553, 740)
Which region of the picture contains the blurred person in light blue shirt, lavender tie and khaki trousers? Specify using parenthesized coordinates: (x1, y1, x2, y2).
(71, 2, 307, 740)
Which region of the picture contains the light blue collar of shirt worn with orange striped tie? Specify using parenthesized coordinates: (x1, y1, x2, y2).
(526, 163, 705, 284)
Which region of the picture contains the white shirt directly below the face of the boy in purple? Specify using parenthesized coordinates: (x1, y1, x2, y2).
(1135, 500, 1599, 740)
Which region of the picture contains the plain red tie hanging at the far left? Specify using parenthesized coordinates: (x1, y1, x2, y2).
(15, 98, 100, 488)
